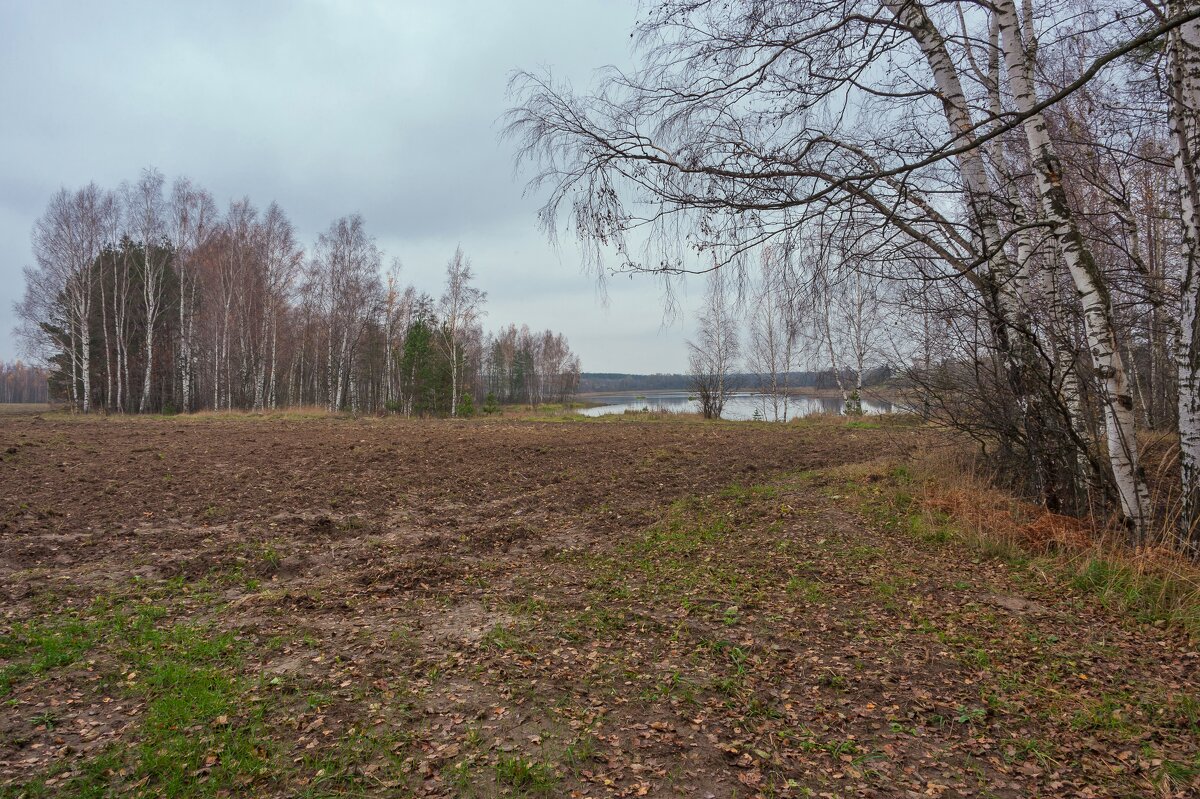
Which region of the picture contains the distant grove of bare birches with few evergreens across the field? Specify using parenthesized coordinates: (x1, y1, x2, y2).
(16, 169, 580, 416)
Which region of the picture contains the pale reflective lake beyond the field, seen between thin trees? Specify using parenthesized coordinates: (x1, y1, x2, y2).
(580, 391, 892, 421)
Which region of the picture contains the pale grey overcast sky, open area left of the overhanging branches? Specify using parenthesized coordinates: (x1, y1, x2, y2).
(0, 0, 698, 372)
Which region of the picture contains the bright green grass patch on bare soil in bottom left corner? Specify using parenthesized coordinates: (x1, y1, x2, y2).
(0, 599, 274, 799)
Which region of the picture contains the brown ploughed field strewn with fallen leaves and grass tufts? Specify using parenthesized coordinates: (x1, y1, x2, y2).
(0, 416, 1200, 797)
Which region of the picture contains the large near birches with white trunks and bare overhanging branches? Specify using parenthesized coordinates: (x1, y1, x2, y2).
(508, 0, 1200, 551)
